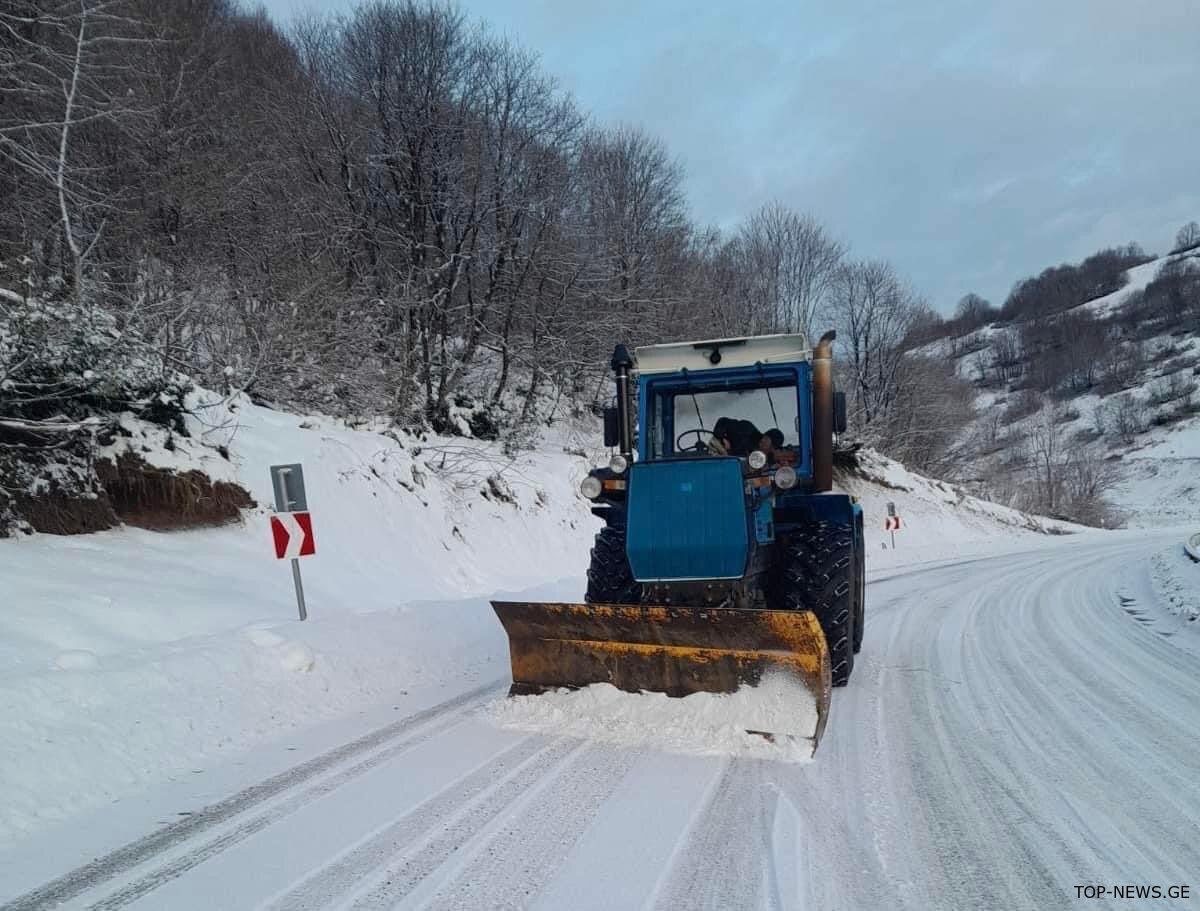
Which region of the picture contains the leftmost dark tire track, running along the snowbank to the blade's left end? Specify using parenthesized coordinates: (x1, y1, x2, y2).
(0, 681, 502, 911)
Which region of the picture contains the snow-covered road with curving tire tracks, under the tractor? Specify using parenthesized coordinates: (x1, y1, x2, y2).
(0, 533, 1200, 911)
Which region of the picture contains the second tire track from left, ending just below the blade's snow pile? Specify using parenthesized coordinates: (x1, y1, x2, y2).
(262, 736, 566, 911)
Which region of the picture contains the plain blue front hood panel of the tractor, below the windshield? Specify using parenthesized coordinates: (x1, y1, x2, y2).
(625, 459, 750, 582)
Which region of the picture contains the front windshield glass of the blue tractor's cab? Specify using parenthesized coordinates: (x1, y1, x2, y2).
(650, 382, 799, 457)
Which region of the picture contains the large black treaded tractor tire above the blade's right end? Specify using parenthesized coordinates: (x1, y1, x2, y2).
(776, 522, 856, 687)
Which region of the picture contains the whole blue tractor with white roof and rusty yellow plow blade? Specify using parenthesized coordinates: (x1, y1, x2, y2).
(494, 332, 864, 748)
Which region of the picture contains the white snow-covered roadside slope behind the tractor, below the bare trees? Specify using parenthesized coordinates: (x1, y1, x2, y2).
(0, 398, 1084, 841)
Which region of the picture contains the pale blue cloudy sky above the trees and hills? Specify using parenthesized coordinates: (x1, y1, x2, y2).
(265, 0, 1200, 311)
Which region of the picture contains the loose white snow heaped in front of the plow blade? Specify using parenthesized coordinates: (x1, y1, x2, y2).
(486, 675, 817, 762)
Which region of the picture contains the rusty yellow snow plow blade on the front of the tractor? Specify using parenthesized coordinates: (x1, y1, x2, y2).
(492, 601, 830, 750)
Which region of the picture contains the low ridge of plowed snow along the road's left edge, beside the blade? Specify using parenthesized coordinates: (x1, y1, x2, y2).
(0, 595, 508, 843)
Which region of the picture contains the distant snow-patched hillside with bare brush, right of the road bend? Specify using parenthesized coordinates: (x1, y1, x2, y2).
(916, 248, 1200, 526)
